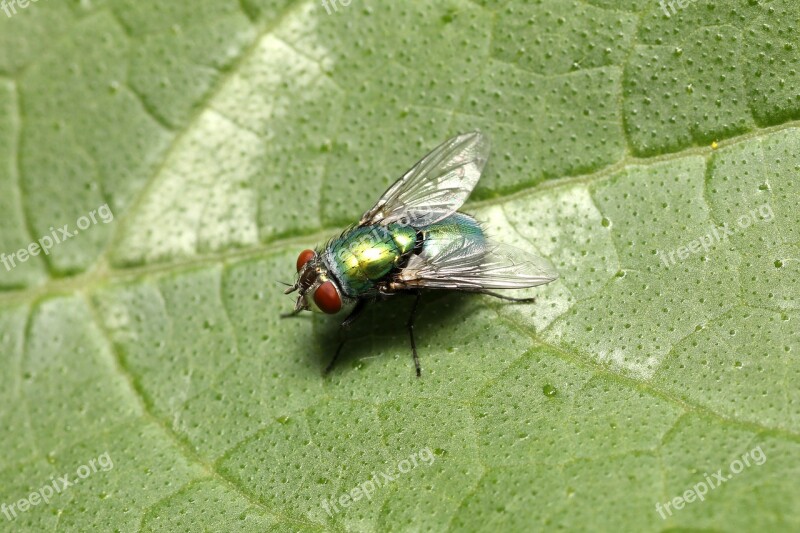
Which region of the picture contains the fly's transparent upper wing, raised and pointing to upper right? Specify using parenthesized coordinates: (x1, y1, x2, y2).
(359, 131, 489, 227)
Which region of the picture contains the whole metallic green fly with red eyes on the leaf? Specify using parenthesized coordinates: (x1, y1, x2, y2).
(284, 131, 558, 377)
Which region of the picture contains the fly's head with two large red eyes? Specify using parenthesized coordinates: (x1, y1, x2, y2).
(286, 250, 349, 315)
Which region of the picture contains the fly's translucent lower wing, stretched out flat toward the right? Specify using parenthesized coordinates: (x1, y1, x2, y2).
(397, 239, 558, 291)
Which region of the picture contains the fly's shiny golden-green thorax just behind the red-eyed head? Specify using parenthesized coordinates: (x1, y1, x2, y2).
(326, 224, 417, 296)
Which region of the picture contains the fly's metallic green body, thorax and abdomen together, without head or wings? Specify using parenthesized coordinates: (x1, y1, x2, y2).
(322, 213, 486, 298)
